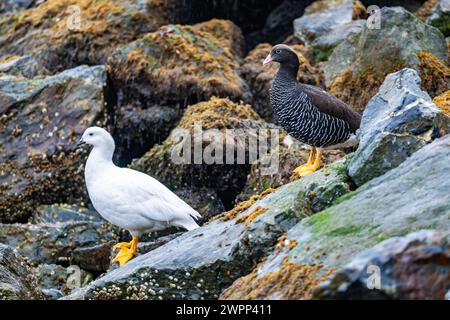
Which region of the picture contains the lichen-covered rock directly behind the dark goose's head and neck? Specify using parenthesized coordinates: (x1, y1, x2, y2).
(241, 43, 323, 122)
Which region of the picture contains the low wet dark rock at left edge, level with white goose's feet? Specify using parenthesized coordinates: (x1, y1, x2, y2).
(0, 221, 116, 265)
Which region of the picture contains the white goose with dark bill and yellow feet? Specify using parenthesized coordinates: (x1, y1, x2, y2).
(77, 127, 201, 266)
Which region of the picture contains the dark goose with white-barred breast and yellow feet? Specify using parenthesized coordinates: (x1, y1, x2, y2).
(263, 44, 361, 176)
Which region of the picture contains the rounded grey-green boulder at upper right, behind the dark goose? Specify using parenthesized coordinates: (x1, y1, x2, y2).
(324, 7, 447, 85)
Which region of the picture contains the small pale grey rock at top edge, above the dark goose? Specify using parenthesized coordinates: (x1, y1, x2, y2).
(294, 0, 366, 43)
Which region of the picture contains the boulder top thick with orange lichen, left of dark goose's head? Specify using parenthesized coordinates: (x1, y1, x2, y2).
(108, 20, 248, 107)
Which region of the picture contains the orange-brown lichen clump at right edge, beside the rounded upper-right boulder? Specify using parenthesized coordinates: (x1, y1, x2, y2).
(417, 52, 450, 97)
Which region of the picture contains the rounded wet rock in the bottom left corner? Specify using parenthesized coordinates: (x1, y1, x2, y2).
(0, 243, 44, 300)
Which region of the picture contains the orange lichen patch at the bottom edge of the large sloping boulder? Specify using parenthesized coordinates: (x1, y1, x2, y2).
(219, 256, 335, 300)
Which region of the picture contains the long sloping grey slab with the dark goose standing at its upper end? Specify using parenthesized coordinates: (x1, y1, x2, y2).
(71, 164, 348, 299)
